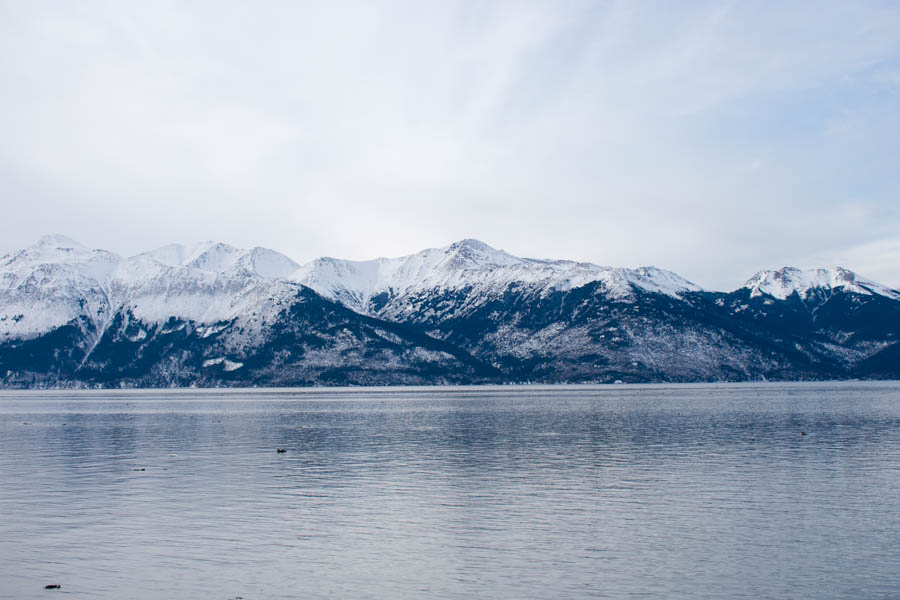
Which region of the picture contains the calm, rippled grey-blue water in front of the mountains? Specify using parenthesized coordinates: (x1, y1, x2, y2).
(0, 383, 900, 600)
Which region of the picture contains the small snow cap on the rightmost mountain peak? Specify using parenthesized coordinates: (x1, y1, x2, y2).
(743, 267, 900, 300)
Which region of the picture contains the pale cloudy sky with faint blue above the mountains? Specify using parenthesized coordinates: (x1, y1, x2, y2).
(0, 0, 900, 290)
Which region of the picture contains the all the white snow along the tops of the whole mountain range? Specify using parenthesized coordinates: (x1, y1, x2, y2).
(0, 235, 900, 339)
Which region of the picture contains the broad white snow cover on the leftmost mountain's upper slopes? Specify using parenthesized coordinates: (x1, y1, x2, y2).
(0, 236, 300, 340)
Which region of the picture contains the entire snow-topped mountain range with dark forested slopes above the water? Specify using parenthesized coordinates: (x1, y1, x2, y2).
(0, 235, 900, 388)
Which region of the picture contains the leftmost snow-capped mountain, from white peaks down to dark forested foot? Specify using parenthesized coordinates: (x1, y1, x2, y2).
(0, 236, 492, 386)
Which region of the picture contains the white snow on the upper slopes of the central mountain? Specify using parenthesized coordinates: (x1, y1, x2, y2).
(293, 240, 701, 313)
